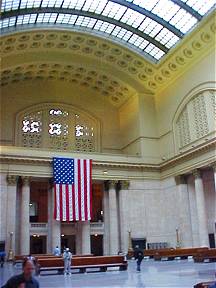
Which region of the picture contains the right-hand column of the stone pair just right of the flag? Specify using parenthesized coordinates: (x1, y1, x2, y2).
(119, 180, 130, 253)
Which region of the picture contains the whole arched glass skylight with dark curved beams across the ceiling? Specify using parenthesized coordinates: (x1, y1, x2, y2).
(0, 0, 216, 61)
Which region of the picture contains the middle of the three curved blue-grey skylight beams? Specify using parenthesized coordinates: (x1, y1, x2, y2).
(110, 0, 184, 38)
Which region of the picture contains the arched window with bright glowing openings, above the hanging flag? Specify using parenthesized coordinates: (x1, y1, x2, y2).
(15, 104, 100, 152)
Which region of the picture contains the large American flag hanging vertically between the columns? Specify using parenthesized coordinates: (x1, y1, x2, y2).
(53, 157, 92, 221)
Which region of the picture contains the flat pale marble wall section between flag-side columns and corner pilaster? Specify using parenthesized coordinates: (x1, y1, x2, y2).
(122, 178, 182, 250)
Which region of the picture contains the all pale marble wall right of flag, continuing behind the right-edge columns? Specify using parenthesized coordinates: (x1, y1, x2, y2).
(121, 171, 216, 251)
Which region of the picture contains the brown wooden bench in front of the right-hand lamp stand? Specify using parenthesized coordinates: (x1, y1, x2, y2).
(154, 247, 208, 260)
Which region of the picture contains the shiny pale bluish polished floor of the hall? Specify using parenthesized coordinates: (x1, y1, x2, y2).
(0, 260, 216, 288)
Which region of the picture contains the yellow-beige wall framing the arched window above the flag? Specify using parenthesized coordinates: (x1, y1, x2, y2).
(1, 80, 121, 153)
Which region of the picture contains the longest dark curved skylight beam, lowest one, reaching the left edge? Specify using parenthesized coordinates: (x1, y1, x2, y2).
(0, 7, 169, 53)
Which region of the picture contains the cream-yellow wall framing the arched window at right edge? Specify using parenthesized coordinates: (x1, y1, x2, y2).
(156, 51, 216, 158)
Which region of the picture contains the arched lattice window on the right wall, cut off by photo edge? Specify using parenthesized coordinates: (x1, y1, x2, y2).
(174, 89, 216, 151)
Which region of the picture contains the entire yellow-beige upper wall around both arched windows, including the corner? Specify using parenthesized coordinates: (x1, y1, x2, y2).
(1, 52, 215, 163)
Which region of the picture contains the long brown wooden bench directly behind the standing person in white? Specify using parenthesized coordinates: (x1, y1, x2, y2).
(37, 256, 128, 274)
